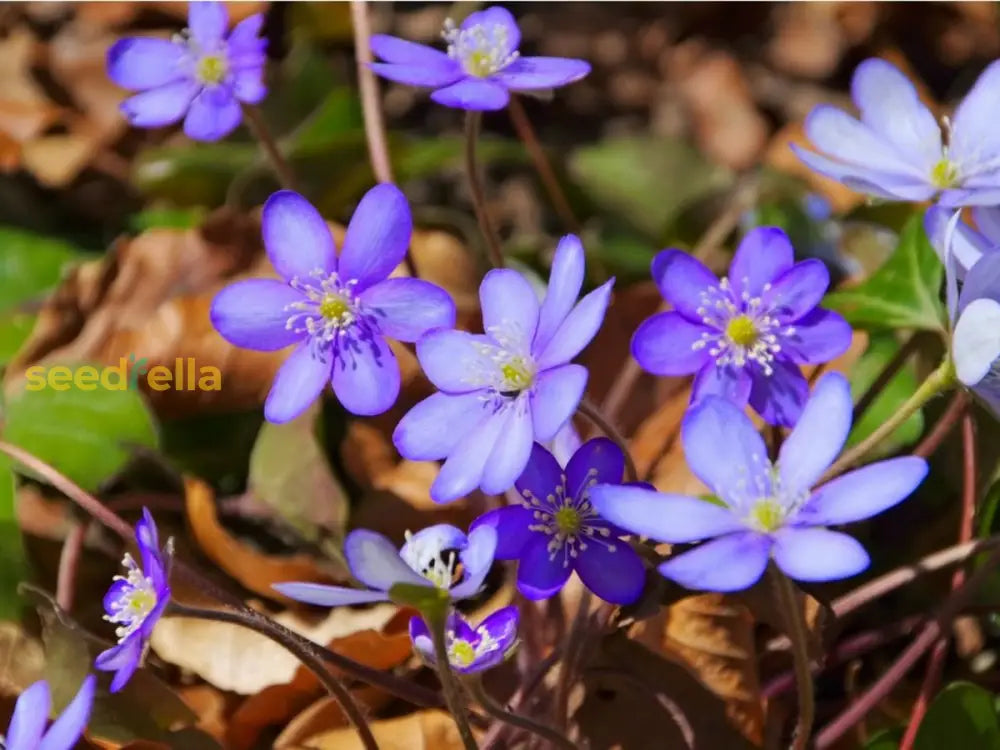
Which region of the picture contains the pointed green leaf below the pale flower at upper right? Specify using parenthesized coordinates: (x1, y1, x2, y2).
(825, 215, 946, 331)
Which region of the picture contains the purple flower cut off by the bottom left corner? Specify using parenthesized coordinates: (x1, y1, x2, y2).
(0, 674, 96, 750)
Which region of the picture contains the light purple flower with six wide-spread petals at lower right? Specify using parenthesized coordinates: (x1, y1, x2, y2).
(590, 373, 927, 591)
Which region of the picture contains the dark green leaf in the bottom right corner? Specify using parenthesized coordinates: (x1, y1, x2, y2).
(913, 682, 1000, 750)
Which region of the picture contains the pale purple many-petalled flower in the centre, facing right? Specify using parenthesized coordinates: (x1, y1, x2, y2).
(392, 235, 613, 503)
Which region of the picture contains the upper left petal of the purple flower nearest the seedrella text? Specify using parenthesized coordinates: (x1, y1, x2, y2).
(261, 190, 337, 281)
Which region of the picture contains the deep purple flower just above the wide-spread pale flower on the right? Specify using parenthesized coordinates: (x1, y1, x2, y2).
(632, 227, 851, 426)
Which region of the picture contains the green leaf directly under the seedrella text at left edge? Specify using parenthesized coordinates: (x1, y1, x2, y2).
(3, 365, 157, 492)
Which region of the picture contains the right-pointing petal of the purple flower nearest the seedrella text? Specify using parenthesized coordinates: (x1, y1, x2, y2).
(361, 278, 455, 343)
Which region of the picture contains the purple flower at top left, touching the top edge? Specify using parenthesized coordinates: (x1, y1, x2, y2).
(108, 2, 267, 141)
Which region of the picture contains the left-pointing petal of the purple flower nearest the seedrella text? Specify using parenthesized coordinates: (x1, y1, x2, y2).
(209, 279, 305, 352)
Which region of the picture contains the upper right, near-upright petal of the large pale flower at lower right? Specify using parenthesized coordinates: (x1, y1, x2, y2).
(778, 372, 854, 494)
